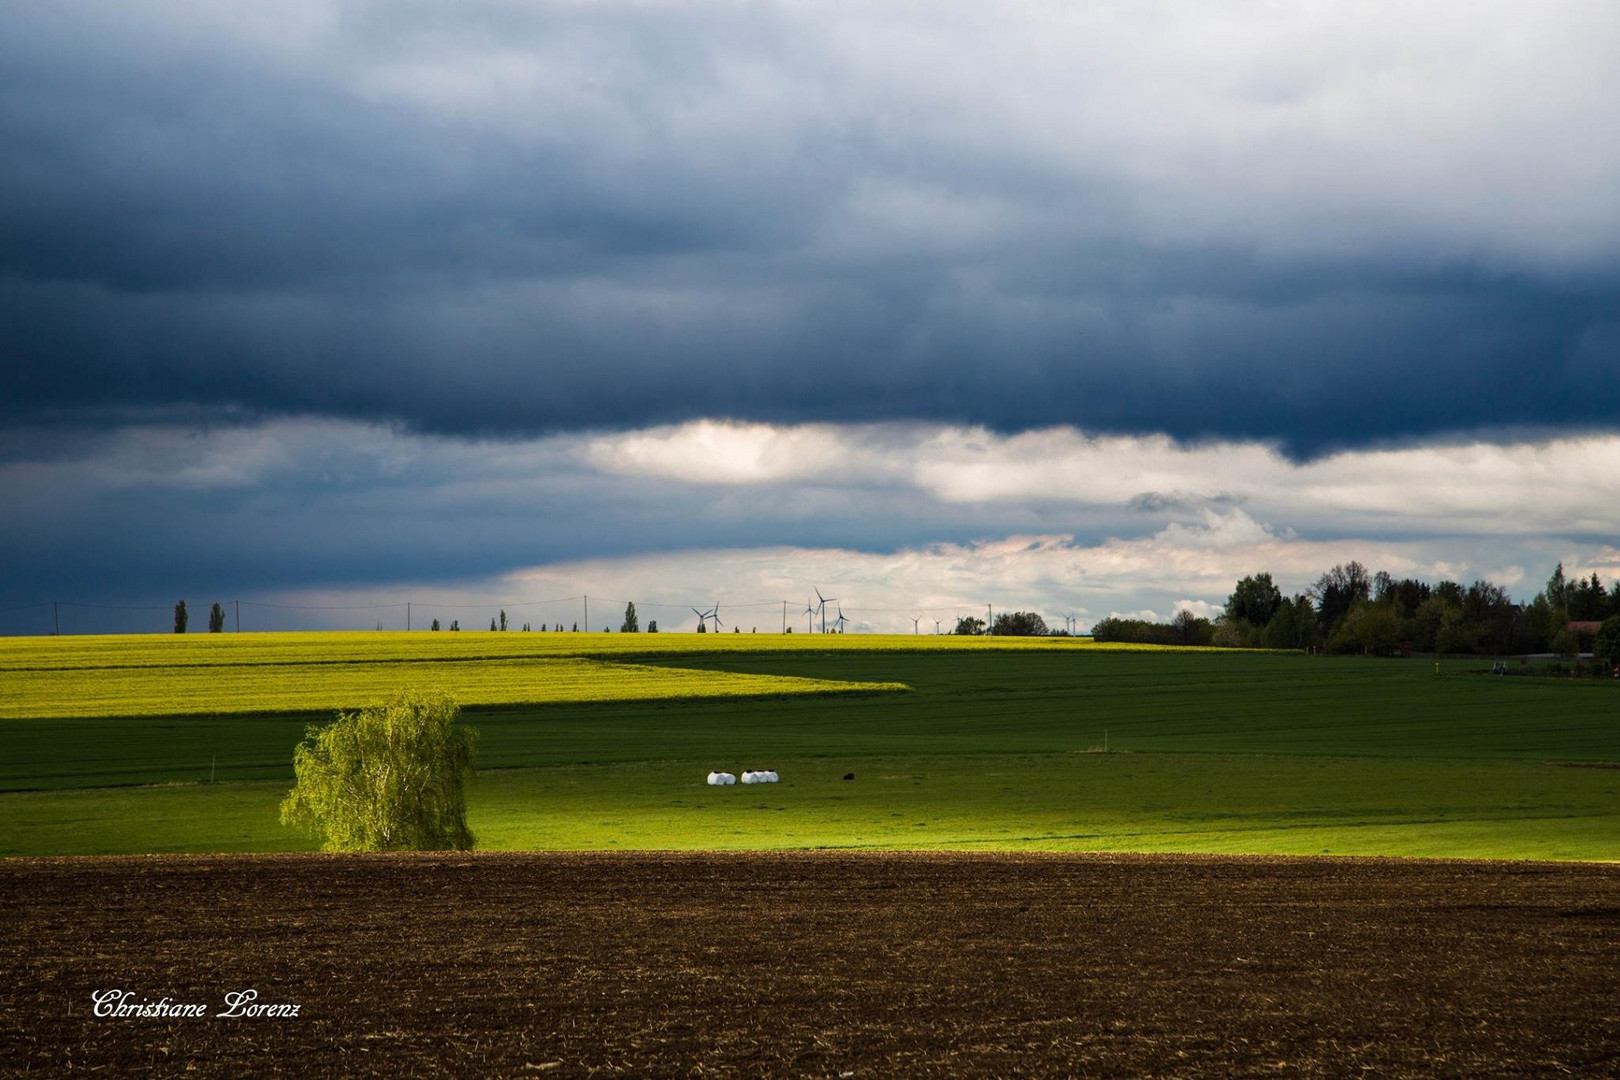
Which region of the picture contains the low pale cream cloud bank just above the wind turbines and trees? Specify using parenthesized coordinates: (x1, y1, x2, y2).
(489, 510, 1505, 631)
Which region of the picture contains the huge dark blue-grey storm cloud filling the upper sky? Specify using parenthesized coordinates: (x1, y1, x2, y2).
(0, 3, 1620, 453)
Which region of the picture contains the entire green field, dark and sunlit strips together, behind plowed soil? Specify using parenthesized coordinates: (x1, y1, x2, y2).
(0, 633, 1620, 860)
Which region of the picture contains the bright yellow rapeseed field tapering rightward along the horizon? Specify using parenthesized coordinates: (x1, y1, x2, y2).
(0, 631, 1211, 719)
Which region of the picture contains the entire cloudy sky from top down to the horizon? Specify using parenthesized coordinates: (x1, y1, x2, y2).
(0, 0, 1620, 633)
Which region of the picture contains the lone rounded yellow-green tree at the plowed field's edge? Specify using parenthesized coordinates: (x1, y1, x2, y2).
(282, 691, 478, 852)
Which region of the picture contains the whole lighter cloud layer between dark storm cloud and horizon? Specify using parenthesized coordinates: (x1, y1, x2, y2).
(0, 421, 1620, 631)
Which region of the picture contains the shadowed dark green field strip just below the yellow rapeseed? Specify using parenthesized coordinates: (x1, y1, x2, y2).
(0, 651, 1620, 790)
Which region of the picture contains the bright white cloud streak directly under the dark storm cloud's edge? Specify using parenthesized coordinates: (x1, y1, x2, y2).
(590, 421, 1620, 542)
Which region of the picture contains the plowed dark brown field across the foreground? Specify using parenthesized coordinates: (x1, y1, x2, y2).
(0, 853, 1620, 1077)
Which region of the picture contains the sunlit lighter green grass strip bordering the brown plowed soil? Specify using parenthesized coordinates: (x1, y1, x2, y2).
(0, 753, 1620, 860)
